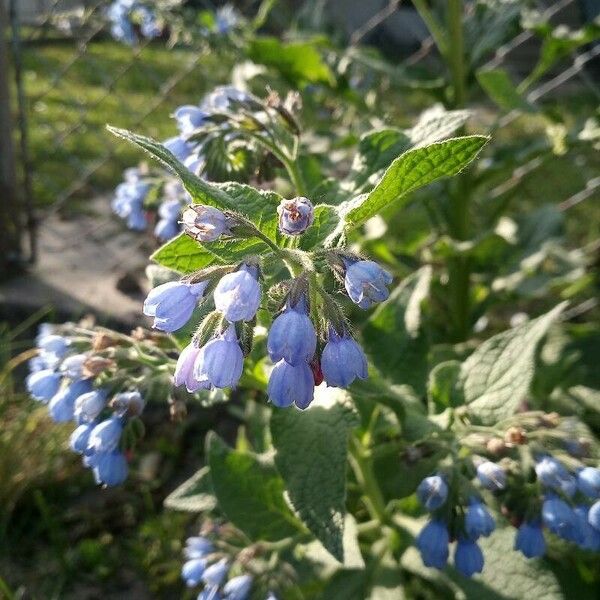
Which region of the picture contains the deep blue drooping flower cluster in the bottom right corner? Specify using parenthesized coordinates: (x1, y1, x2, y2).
(416, 456, 600, 577)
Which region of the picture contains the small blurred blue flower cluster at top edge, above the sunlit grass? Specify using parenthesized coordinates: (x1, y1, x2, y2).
(106, 0, 162, 45)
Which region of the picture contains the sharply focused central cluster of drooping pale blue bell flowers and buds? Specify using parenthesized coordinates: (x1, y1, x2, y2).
(144, 198, 391, 409)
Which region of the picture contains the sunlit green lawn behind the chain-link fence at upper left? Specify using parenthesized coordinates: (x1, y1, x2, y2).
(23, 40, 234, 206)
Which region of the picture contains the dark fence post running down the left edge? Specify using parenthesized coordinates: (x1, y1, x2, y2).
(0, 2, 23, 279)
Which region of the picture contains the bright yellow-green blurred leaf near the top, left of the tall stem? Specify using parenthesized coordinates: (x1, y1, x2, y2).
(248, 37, 335, 85)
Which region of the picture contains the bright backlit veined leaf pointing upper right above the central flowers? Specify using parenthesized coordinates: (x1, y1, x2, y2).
(340, 135, 489, 228)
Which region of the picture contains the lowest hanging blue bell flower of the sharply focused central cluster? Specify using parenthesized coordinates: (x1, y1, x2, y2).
(267, 360, 315, 409)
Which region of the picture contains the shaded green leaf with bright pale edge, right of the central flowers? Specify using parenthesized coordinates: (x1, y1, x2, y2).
(363, 267, 431, 394)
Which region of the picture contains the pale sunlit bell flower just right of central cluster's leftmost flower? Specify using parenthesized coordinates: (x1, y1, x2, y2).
(213, 265, 260, 323)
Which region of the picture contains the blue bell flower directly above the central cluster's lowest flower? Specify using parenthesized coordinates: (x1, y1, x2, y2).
(267, 299, 317, 366)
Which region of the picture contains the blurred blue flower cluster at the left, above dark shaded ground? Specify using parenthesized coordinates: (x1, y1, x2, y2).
(26, 325, 144, 486)
